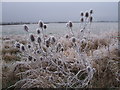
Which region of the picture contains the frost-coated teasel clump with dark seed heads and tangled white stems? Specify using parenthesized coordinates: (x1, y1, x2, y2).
(11, 12, 94, 88)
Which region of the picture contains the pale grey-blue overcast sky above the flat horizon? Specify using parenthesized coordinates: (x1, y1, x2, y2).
(2, 2, 118, 22)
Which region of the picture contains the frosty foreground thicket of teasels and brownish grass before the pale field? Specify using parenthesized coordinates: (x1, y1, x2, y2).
(3, 11, 120, 89)
